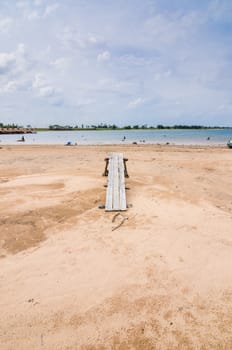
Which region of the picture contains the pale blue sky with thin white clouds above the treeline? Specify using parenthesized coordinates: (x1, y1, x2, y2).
(0, 0, 232, 127)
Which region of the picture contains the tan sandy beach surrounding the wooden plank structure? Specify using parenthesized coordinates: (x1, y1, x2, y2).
(0, 145, 232, 350)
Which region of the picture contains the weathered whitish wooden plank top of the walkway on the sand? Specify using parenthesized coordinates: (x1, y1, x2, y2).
(105, 153, 127, 211)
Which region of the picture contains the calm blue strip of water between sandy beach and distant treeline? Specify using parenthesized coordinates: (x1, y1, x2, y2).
(0, 129, 232, 145)
